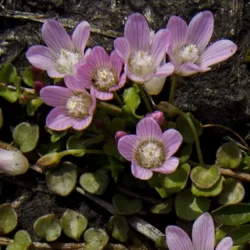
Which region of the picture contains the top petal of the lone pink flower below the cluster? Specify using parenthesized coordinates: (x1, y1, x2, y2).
(136, 117, 162, 140)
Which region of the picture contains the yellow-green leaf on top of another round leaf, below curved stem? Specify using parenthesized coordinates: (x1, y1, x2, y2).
(190, 165, 220, 189)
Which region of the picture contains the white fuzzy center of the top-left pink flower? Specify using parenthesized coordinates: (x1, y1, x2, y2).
(56, 49, 81, 74)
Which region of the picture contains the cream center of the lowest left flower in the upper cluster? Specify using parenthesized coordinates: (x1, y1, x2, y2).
(66, 92, 92, 119)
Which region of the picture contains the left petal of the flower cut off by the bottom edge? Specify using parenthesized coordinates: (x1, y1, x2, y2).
(166, 226, 193, 250)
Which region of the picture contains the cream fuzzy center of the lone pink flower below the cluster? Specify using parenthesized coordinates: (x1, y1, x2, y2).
(135, 140, 166, 169)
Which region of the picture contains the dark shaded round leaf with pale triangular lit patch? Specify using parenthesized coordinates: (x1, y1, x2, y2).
(175, 189, 210, 221)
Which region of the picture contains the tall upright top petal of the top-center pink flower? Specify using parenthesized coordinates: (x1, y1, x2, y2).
(124, 13, 150, 51)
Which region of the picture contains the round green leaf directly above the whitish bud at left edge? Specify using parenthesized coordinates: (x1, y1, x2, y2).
(12, 122, 39, 153)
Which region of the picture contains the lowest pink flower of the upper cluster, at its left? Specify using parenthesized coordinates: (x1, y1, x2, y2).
(40, 75, 96, 131)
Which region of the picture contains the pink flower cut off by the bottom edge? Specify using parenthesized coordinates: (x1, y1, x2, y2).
(166, 213, 233, 250)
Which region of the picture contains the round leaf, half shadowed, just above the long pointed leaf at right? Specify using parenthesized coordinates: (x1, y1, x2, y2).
(218, 178, 245, 205)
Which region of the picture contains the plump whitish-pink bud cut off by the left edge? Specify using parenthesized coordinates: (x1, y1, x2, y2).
(0, 148, 29, 176)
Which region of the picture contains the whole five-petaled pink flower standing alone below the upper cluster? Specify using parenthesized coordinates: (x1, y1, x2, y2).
(118, 117, 182, 180)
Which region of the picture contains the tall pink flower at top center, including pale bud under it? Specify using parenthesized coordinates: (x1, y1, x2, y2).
(114, 13, 174, 95)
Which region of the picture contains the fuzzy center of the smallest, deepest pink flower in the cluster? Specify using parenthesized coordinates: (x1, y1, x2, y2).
(92, 68, 117, 91)
